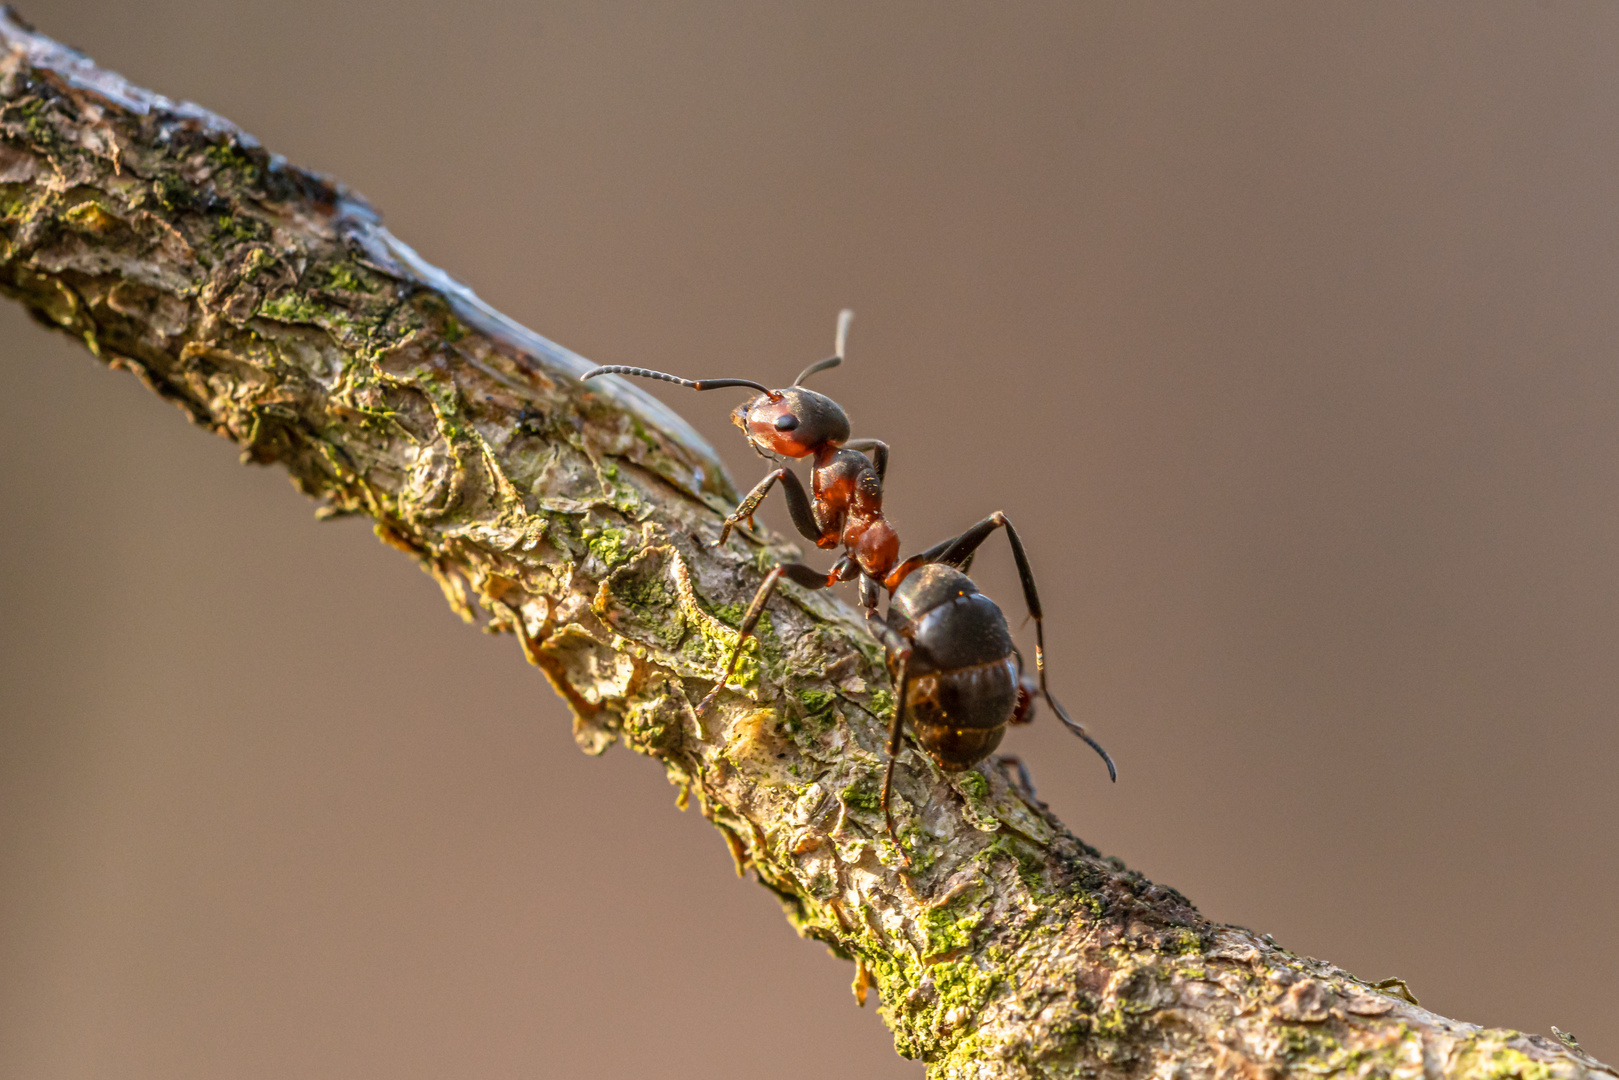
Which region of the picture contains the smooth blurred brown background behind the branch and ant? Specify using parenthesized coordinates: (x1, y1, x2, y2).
(0, 0, 1619, 1080)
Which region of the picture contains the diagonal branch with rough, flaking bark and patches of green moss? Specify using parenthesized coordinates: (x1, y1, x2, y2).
(0, 11, 1619, 1080)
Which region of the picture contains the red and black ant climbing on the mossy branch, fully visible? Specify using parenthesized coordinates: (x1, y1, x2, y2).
(581, 309, 1119, 857)
